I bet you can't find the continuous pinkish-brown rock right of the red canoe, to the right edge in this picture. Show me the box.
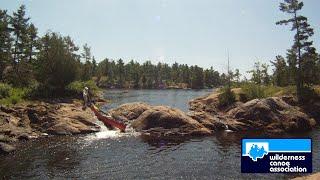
[109,89,320,136]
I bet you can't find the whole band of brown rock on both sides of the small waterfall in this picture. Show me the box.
[0,90,320,154]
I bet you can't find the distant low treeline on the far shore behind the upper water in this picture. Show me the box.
[94,59,231,89]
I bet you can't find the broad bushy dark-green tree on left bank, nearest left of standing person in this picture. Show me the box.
[36,33,78,95]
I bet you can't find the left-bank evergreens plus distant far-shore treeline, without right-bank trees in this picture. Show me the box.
[0,5,232,94]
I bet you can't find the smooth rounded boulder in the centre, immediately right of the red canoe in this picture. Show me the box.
[110,103,212,136]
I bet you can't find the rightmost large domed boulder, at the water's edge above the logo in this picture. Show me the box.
[227,97,316,132]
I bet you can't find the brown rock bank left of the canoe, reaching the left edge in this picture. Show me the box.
[0,100,100,154]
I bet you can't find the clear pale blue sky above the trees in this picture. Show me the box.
[0,0,320,76]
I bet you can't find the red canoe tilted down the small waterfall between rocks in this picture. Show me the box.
[90,104,126,132]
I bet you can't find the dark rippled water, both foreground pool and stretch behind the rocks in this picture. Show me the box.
[0,90,320,179]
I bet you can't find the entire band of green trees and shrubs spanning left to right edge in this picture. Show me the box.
[0,1,320,103]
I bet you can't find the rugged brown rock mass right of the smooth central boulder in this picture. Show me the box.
[189,89,319,133]
